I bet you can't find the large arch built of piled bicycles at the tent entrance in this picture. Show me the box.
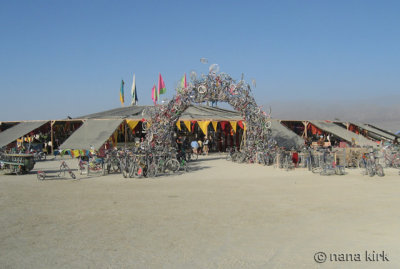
[144,65,271,161]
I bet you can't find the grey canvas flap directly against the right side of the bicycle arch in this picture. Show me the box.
[271,119,304,149]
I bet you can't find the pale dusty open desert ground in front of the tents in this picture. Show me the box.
[0,155,400,268]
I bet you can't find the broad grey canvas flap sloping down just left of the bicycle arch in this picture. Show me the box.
[60,119,123,150]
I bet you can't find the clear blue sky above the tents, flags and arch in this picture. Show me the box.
[0,0,400,121]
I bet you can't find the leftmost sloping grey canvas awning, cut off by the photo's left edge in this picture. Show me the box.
[0,121,49,148]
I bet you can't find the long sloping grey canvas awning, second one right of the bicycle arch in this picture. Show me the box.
[310,121,377,147]
